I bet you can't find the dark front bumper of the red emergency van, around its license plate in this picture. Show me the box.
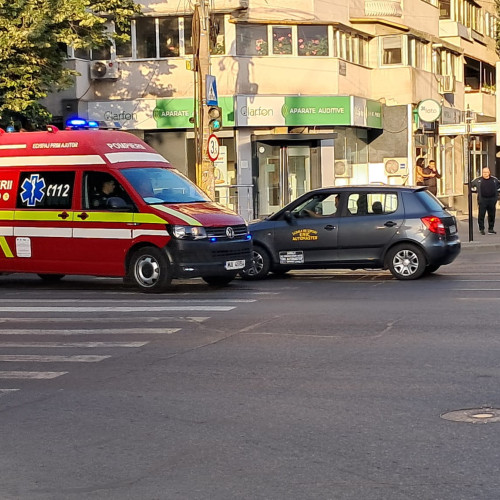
[165,238,252,278]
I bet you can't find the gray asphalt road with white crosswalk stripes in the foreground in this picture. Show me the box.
[0,251,500,500]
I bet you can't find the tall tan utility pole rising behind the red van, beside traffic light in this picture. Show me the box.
[192,0,215,199]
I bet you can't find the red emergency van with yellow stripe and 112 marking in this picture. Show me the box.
[0,127,251,292]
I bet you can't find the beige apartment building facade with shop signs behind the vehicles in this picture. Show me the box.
[47,0,497,220]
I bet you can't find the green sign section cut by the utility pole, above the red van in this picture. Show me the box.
[153,97,234,129]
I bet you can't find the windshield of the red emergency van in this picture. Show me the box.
[121,168,210,205]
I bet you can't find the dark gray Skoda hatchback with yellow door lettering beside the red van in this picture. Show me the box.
[242,184,460,280]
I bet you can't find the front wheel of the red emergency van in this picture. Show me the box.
[127,247,172,293]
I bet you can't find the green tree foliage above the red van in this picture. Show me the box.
[0,0,139,129]
